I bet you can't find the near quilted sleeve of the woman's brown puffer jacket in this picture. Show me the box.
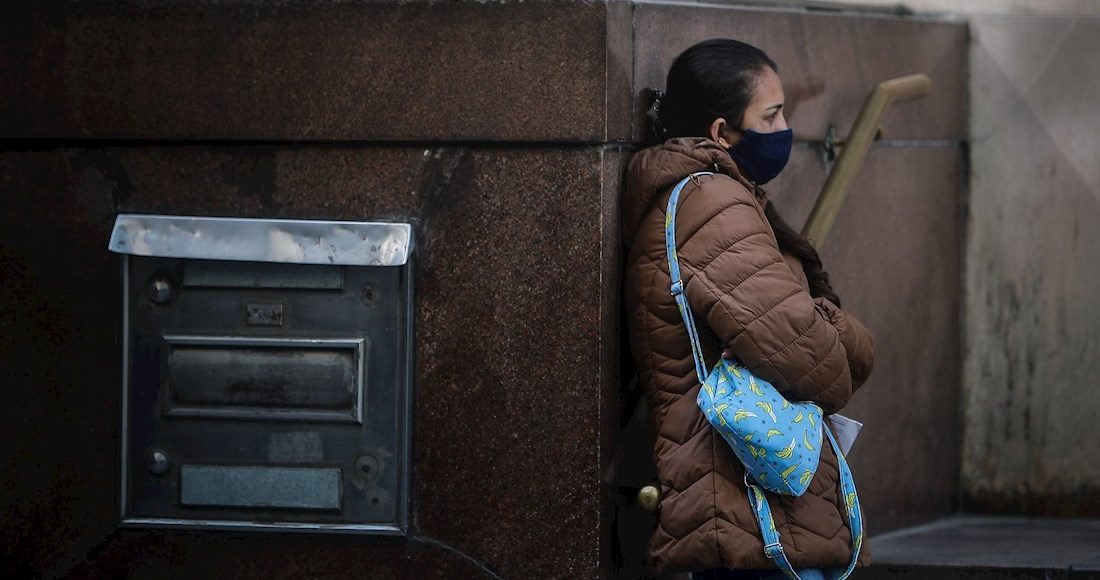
[677,176,869,414]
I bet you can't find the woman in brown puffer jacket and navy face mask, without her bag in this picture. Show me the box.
[623,40,873,578]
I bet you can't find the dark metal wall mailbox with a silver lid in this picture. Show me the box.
[110,215,413,534]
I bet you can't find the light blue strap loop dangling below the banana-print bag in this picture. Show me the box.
[745,425,864,580]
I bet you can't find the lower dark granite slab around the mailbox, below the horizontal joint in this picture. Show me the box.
[0,145,618,578]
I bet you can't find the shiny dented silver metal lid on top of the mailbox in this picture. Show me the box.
[108,214,413,266]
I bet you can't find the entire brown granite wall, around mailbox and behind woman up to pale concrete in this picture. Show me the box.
[0,0,967,578]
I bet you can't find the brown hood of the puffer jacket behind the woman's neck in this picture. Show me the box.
[623,138,763,248]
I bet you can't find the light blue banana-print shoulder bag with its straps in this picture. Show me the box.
[664,172,864,579]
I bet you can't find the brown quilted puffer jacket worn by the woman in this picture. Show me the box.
[623,139,873,572]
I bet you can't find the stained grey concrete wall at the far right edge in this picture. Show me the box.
[827,0,1100,515]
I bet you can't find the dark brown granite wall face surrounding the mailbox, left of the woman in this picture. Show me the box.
[0,0,631,578]
